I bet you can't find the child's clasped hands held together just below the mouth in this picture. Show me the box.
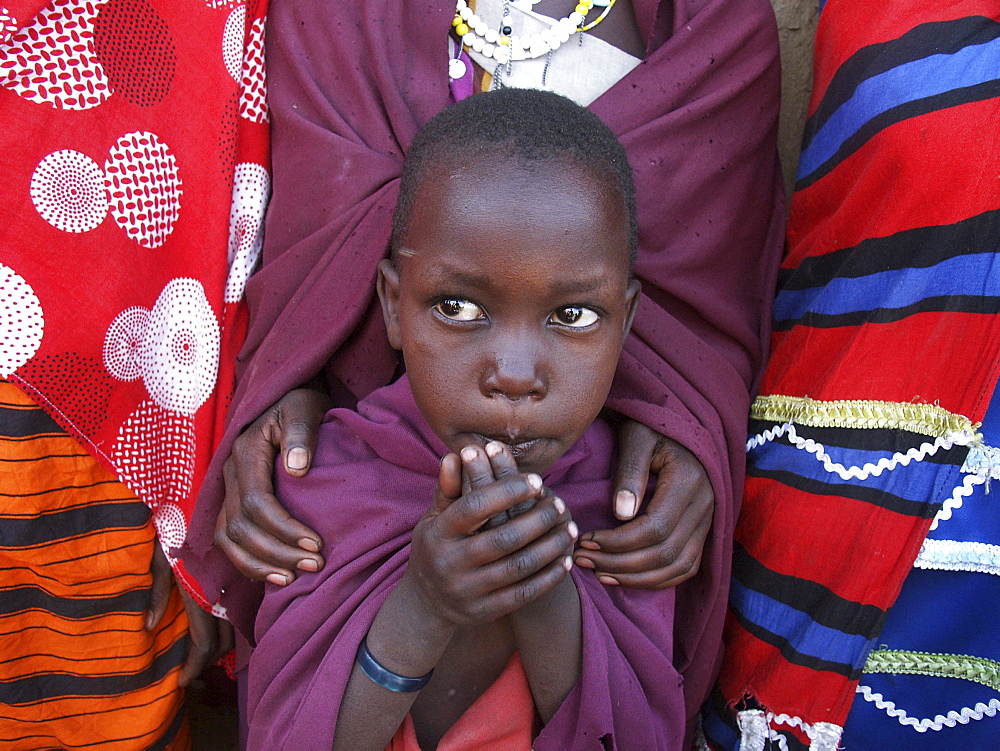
[407,442,577,625]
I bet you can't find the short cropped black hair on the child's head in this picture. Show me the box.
[391,88,638,266]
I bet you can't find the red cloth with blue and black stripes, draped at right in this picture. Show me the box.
[704,0,1000,750]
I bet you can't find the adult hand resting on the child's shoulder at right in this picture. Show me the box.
[576,419,715,589]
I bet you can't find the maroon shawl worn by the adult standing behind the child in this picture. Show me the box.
[185,0,784,717]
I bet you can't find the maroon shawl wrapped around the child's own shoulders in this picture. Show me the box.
[248,377,685,751]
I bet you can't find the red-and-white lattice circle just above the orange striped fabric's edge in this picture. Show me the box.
[111,400,195,520]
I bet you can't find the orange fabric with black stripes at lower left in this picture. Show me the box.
[0,382,190,751]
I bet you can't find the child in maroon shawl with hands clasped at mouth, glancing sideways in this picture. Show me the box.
[241,89,684,750]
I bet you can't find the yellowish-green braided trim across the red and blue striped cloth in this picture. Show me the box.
[750,394,979,438]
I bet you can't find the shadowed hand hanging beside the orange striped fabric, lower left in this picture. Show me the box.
[146,540,234,688]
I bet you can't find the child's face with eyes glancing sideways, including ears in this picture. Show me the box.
[379,158,639,473]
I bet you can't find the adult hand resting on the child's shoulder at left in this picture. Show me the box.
[215,388,333,585]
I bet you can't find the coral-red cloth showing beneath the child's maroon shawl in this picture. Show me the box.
[386,652,535,751]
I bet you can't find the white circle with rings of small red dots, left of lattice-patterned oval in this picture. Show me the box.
[29,149,108,232]
